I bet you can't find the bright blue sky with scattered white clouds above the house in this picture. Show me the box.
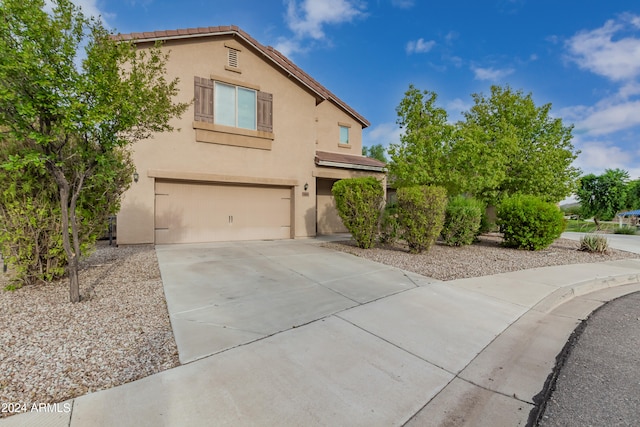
[74,0,640,178]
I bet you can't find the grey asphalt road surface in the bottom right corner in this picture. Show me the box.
[538,292,640,427]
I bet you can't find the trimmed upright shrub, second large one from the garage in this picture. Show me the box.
[397,186,447,253]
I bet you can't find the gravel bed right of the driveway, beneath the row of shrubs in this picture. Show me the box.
[323,234,640,281]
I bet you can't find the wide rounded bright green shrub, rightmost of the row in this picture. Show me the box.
[497,194,564,251]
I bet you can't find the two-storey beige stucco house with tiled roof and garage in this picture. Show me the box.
[117,27,385,244]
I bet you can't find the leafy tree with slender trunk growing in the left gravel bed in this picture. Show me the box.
[0,0,187,302]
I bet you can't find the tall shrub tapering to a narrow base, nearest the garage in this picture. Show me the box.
[331,177,384,249]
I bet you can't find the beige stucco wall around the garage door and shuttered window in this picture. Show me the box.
[118,36,376,244]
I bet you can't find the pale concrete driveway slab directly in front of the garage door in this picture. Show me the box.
[156,240,436,363]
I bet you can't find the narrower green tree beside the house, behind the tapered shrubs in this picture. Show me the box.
[388,85,454,189]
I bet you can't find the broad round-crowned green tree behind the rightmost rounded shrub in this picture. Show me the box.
[452,86,579,204]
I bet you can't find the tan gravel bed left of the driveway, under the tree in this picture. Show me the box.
[0,242,179,417]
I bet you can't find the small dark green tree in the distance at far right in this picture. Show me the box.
[576,169,629,230]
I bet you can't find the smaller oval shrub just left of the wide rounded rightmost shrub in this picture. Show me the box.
[441,196,485,246]
